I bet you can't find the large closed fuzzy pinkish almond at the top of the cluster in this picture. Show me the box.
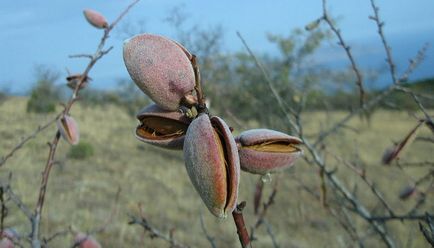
[123,34,195,111]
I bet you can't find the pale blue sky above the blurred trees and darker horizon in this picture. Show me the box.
[0,0,434,93]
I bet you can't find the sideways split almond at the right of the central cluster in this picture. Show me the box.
[236,129,303,175]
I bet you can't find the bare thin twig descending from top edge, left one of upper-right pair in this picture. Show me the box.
[322,0,365,107]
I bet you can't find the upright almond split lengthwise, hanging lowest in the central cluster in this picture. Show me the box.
[184,114,240,218]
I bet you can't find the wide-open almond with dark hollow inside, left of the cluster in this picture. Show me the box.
[136,104,191,150]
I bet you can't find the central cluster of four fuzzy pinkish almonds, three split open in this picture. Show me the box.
[123,34,303,218]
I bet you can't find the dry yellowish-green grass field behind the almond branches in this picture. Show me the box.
[0,97,434,247]
